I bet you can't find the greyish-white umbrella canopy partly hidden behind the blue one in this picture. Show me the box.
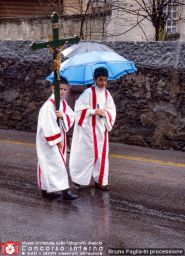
[62,42,114,58]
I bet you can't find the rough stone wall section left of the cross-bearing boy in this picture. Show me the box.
[0,41,52,131]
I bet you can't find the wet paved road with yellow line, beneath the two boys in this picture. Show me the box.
[0,130,185,255]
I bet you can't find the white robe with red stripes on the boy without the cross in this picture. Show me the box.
[69,86,116,186]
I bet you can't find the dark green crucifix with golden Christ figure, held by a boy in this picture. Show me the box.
[30,12,80,114]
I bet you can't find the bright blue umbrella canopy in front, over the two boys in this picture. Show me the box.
[46,50,137,85]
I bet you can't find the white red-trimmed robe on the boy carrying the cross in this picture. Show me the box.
[36,95,74,192]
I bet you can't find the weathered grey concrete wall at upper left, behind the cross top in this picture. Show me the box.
[0,16,109,41]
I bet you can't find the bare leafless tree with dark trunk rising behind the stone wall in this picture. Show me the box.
[108,0,185,41]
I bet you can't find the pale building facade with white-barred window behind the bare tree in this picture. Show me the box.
[106,0,185,41]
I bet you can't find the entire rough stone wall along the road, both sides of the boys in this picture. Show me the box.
[0,41,185,150]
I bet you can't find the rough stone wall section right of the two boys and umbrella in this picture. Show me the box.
[109,42,185,150]
